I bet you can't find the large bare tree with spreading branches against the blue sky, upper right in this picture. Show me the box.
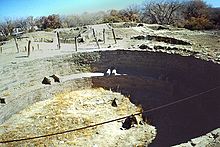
[143,0,182,24]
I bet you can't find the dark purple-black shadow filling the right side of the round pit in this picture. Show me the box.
[89,51,220,146]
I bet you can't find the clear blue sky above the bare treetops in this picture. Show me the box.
[0,0,220,21]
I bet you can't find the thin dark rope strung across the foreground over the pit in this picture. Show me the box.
[0,86,220,143]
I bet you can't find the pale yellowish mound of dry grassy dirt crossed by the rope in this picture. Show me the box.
[0,89,156,146]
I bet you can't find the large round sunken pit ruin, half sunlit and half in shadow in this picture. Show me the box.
[0,24,220,146]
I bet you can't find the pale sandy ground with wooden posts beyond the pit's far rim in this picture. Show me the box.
[0,23,220,65]
